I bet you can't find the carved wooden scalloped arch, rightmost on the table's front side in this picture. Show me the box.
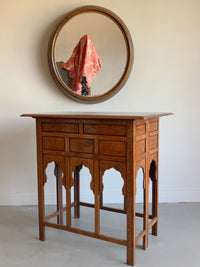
[99,161,127,196]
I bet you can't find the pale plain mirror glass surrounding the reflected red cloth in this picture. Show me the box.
[54,13,127,96]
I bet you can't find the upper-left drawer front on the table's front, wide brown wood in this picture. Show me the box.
[42,122,79,133]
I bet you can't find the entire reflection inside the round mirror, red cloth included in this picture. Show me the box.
[55,13,127,96]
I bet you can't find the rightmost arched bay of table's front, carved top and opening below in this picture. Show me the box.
[99,160,126,239]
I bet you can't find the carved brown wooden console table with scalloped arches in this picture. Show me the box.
[22,113,171,265]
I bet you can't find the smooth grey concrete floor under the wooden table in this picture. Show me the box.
[0,203,200,267]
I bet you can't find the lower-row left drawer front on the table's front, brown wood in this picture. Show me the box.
[42,136,65,151]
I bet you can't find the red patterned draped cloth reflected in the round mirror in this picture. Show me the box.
[62,35,101,94]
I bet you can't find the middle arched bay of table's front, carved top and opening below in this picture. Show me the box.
[70,158,95,231]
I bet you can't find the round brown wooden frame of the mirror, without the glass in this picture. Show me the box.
[48,5,134,104]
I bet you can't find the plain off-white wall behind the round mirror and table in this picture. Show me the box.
[0,0,200,205]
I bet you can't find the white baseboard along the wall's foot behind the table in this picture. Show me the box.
[0,191,200,206]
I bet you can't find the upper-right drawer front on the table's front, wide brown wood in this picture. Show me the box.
[83,124,126,136]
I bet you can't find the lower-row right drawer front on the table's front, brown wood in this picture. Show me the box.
[99,141,126,157]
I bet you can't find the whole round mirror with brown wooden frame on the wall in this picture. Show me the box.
[49,6,133,103]
